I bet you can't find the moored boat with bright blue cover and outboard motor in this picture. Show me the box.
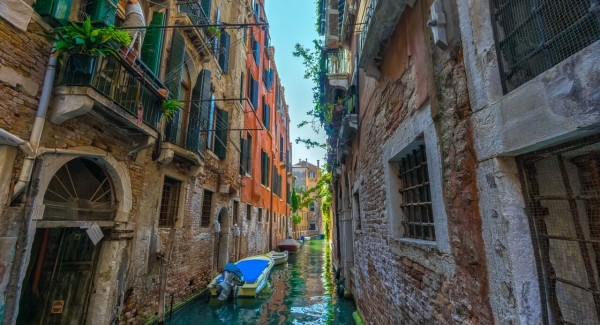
[208,254,275,300]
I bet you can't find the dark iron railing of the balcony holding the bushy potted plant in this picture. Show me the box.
[62,51,166,130]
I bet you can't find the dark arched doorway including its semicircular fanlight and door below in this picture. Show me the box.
[17,158,117,324]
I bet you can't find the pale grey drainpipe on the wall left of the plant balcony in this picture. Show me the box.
[10,46,58,203]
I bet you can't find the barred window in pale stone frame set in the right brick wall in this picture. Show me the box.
[398,144,435,241]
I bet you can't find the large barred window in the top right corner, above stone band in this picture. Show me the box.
[491,0,600,93]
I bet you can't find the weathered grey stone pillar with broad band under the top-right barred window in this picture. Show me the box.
[457,1,600,324]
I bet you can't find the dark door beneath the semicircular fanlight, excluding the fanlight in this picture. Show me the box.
[17,228,102,325]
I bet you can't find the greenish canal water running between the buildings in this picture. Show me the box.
[165,240,355,325]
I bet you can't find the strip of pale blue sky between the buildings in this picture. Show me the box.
[265,0,325,166]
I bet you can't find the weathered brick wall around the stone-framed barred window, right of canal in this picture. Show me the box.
[346,1,493,324]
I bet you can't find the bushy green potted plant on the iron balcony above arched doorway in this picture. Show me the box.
[43,17,131,74]
